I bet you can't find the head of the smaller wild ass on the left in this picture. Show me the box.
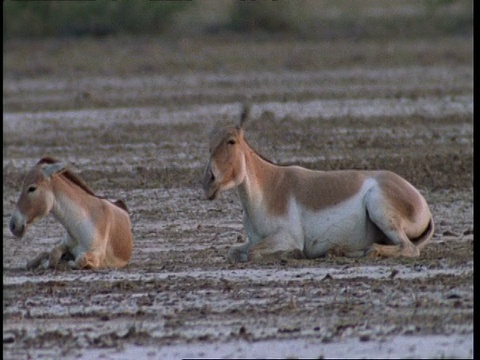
[10,158,66,237]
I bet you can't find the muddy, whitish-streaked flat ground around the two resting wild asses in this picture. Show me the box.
[3,34,474,359]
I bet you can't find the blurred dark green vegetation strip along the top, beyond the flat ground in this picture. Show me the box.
[3,0,473,39]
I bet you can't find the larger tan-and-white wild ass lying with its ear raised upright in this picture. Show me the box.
[203,107,434,262]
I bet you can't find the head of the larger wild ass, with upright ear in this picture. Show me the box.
[203,106,249,200]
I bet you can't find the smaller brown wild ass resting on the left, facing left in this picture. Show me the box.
[10,157,133,269]
